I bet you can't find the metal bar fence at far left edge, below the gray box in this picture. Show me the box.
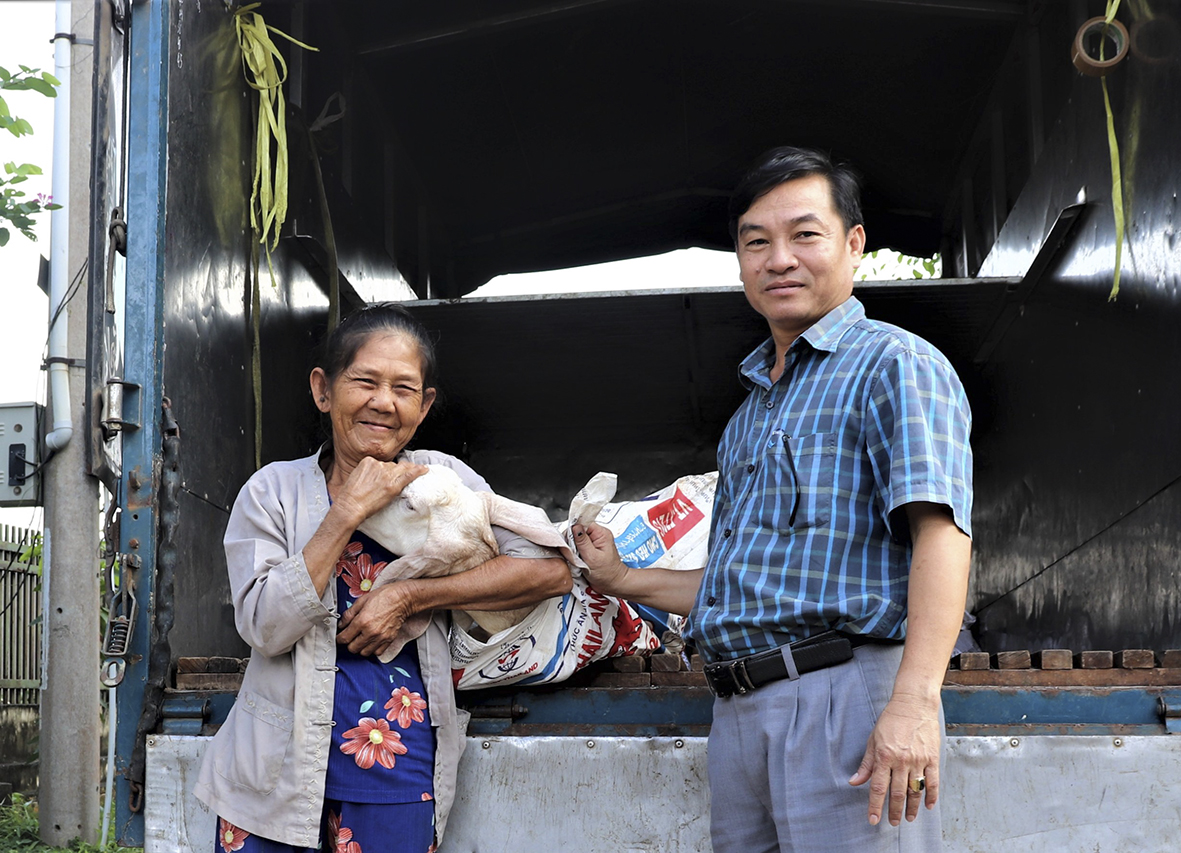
[0,525,41,708]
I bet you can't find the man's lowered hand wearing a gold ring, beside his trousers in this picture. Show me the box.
[849,695,941,826]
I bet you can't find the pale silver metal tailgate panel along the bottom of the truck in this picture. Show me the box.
[144,735,1181,853]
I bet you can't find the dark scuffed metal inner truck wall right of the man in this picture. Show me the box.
[970,4,1181,651]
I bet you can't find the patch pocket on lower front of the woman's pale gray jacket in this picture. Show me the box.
[215,690,294,794]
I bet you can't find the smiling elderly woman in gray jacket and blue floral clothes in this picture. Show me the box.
[196,304,570,853]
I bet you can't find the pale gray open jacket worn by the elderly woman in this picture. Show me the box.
[195,450,529,847]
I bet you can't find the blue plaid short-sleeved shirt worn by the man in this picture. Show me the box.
[687,297,972,660]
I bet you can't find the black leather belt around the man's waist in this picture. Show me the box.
[705,631,875,698]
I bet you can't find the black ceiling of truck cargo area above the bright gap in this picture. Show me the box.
[292,0,1072,292]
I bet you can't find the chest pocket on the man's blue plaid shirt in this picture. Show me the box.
[768,432,836,530]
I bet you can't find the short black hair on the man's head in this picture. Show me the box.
[730,145,863,245]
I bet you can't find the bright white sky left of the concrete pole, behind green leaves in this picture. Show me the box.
[0,0,54,527]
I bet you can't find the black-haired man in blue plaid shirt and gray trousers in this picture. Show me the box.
[575,148,972,853]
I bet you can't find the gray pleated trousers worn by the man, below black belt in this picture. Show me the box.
[709,645,946,853]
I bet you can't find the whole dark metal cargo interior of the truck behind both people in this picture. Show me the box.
[147,0,1181,655]
